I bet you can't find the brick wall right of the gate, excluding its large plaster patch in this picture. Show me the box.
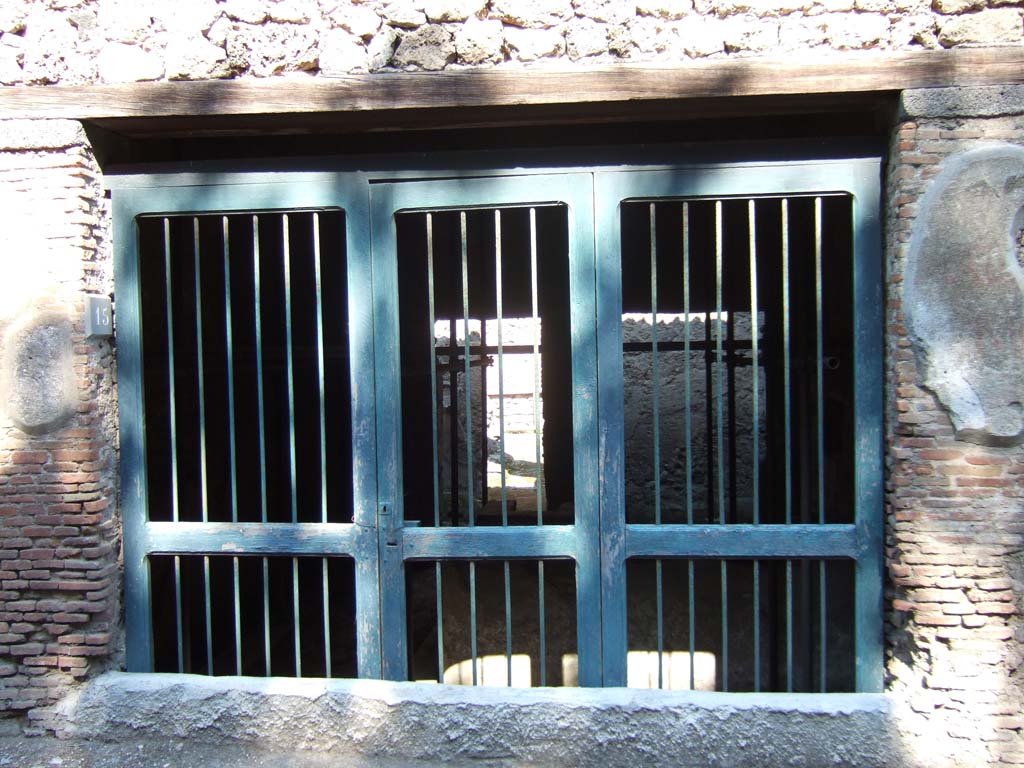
[886,111,1024,766]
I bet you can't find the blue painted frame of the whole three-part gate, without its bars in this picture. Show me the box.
[113,151,883,691]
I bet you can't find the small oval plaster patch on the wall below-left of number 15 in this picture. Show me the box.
[0,311,78,434]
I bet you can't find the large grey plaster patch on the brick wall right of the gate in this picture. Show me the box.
[904,144,1024,445]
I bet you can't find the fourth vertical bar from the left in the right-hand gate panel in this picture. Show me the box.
[746,200,761,692]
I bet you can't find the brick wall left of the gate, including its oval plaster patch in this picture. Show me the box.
[0,121,121,712]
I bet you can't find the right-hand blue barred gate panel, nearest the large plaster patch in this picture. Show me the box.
[595,161,883,691]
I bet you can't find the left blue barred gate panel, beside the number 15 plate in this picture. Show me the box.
[115,175,380,677]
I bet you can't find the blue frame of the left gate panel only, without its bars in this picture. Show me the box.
[113,173,381,678]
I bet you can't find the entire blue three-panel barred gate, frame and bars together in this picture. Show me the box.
[114,153,882,690]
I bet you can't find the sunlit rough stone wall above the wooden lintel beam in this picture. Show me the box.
[0,0,1024,85]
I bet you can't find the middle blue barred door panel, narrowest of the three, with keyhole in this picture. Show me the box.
[371,173,600,685]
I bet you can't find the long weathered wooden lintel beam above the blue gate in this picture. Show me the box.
[0,46,1024,120]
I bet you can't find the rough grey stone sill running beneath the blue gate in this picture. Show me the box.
[44,673,906,768]
